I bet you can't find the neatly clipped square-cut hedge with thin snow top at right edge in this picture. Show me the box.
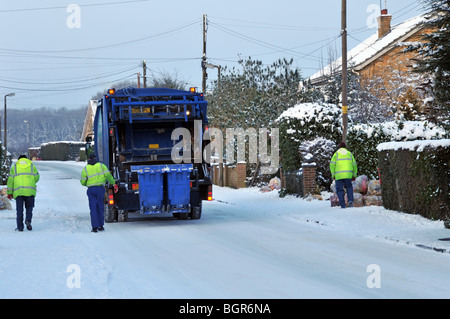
[377,139,450,220]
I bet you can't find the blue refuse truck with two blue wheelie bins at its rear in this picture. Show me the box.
[86,88,212,222]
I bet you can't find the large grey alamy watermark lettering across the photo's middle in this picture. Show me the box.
[171,120,279,174]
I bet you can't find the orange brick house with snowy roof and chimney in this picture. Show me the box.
[310,9,431,111]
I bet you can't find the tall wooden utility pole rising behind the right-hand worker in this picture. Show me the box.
[341,0,348,142]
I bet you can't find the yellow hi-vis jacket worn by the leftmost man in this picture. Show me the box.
[7,158,39,198]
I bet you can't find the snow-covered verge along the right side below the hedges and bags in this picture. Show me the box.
[229,186,450,255]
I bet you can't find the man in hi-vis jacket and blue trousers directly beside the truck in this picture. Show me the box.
[80,154,117,233]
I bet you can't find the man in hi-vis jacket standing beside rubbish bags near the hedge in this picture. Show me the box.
[330,142,358,208]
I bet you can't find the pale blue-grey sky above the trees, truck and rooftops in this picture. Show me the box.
[0,0,425,110]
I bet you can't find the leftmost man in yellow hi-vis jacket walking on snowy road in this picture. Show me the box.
[7,155,39,231]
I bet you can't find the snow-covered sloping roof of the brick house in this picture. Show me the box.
[310,14,426,82]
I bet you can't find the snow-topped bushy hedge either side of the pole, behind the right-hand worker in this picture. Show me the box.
[277,103,448,185]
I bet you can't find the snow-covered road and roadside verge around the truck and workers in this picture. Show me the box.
[0,162,450,299]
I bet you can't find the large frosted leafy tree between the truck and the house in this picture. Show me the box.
[207,58,320,129]
